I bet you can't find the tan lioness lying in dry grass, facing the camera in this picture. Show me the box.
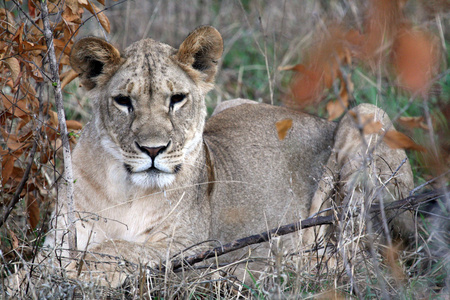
[27,26,412,285]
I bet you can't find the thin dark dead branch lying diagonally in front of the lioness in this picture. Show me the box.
[168,190,447,271]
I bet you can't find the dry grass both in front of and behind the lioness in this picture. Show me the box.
[0,0,450,299]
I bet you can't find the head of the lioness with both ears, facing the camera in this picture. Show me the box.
[70,26,223,187]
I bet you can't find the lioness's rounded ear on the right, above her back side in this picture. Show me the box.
[176,26,223,83]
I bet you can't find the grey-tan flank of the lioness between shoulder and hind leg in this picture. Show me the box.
[204,104,336,240]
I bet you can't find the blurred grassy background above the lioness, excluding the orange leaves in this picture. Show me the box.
[74,0,450,113]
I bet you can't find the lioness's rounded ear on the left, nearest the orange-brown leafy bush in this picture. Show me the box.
[70,37,122,90]
